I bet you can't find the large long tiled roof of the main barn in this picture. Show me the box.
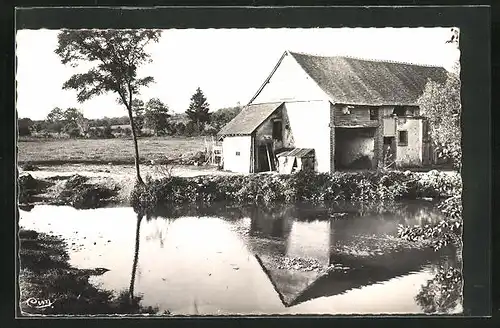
[288,52,447,106]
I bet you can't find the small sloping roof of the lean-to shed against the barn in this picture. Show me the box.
[218,102,283,136]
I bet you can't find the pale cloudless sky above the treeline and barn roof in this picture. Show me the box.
[16,27,460,120]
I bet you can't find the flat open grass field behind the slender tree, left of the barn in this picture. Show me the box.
[18,137,205,165]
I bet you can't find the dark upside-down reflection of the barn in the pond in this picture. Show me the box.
[244,206,449,306]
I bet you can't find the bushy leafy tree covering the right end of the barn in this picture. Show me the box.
[418,73,462,168]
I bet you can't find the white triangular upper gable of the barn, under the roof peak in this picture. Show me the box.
[252,55,327,104]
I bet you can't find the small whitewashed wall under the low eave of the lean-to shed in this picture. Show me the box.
[222,136,252,173]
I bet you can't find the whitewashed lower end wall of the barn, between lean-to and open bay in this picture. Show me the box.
[284,101,330,172]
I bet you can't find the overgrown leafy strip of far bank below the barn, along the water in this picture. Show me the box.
[131,171,461,211]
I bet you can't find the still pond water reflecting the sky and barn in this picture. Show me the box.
[20,203,460,315]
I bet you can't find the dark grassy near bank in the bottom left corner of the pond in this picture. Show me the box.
[19,230,157,315]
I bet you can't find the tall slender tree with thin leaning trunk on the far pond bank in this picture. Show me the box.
[55,29,161,184]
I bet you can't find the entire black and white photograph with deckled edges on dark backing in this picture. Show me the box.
[15,15,464,318]
